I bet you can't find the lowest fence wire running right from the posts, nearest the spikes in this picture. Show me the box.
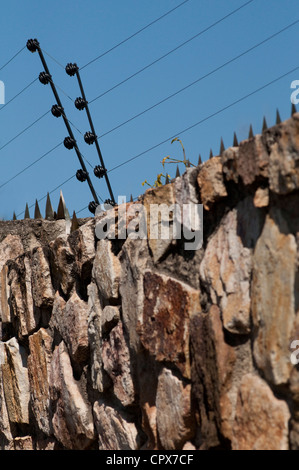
[108,62,299,173]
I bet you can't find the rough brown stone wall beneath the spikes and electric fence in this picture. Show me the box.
[0,114,299,450]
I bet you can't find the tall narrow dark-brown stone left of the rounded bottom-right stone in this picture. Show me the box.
[190,305,238,449]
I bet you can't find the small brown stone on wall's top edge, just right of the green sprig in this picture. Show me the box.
[197,157,227,210]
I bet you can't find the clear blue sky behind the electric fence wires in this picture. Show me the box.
[0,0,299,219]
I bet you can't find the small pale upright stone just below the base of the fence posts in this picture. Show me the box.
[93,240,121,300]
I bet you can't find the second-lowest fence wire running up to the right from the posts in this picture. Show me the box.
[97,19,299,139]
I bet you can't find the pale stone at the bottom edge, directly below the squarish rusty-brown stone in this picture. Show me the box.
[156,368,195,450]
